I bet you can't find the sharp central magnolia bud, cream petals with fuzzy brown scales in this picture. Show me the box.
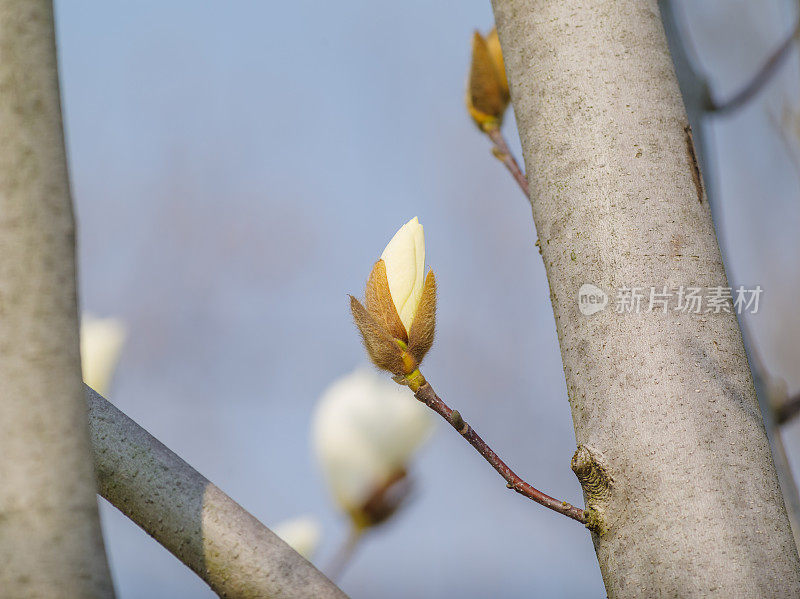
[350,217,436,376]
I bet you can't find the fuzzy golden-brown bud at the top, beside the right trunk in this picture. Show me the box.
[467,28,511,131]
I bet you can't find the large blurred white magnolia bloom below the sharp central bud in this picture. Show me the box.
[312,370,433,528]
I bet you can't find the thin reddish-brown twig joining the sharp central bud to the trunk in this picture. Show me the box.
[414,382,586,524]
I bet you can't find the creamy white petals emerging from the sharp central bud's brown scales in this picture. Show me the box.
[381,216,425,333]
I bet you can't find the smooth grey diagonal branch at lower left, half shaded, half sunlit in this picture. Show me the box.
[86,387,346,599]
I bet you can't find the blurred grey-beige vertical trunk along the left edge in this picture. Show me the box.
[0,0,113,598]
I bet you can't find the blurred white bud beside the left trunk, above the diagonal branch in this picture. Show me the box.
[81,314,127,396]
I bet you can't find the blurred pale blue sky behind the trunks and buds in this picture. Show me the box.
[56,0,800,599]
